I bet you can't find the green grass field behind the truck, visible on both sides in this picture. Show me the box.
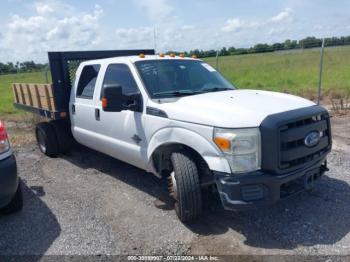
[0,46,350,119]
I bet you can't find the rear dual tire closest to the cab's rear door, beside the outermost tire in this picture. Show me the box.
[50,120,72,154]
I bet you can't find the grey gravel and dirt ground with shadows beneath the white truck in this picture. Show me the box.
[0,117,350,256]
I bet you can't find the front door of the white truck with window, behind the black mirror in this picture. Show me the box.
[95,63,147,168]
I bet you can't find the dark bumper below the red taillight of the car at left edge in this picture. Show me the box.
[0,155,18,208]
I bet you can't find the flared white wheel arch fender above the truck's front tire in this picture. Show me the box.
[147,127,231,173]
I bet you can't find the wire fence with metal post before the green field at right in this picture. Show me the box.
[208,42,350,113]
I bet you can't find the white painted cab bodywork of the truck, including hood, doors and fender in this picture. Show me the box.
[70,56,314,174]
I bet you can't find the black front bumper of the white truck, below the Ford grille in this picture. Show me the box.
[214,159,328,210]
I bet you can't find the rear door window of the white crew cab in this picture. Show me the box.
[77,65,101,99]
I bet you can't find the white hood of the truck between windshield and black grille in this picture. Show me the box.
[152,90,315,128]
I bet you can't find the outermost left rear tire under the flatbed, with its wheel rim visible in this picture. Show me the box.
[35,122,59,157]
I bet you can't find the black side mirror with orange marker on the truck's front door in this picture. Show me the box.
[102,84,124,112]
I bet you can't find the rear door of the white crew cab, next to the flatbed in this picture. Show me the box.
[70,64,101,148]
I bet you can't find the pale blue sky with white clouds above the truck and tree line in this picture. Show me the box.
[0,0,350,62]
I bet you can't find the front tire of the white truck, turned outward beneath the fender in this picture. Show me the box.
[169,152,202,222]
